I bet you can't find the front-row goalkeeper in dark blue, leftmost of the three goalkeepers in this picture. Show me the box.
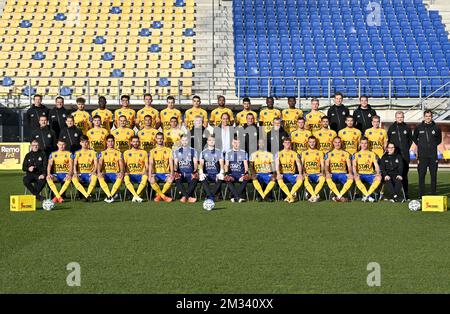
[173,134,198,203]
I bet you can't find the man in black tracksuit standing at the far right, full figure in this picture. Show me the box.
[413,110,442,198]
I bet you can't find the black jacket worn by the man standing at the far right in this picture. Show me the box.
[413,121,442,160]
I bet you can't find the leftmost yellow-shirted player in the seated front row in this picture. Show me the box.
[47,139,73,203]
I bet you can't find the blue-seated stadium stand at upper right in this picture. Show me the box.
[233,0,450,98]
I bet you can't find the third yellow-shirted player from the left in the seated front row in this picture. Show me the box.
[98,134,124,203]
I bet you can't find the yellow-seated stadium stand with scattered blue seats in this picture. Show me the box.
[0,0,196,98]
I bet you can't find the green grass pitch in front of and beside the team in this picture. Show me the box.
[0,171,450,293]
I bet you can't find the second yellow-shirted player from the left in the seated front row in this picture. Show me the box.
[72,135,97,202]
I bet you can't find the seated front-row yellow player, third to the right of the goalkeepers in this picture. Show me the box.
[300,136,325,202]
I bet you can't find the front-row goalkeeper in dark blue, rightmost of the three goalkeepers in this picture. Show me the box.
[225,137,250,203]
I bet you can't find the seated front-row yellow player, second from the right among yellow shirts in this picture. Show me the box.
[325,136,353,202]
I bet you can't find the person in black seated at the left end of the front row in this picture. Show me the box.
[22,140,47,201]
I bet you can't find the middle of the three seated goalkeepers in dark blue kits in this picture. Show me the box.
[198,135,225,201]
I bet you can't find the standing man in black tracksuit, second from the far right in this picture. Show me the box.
[387,111,412,199]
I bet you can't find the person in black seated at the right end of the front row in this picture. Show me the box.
[379,143,403,202]
